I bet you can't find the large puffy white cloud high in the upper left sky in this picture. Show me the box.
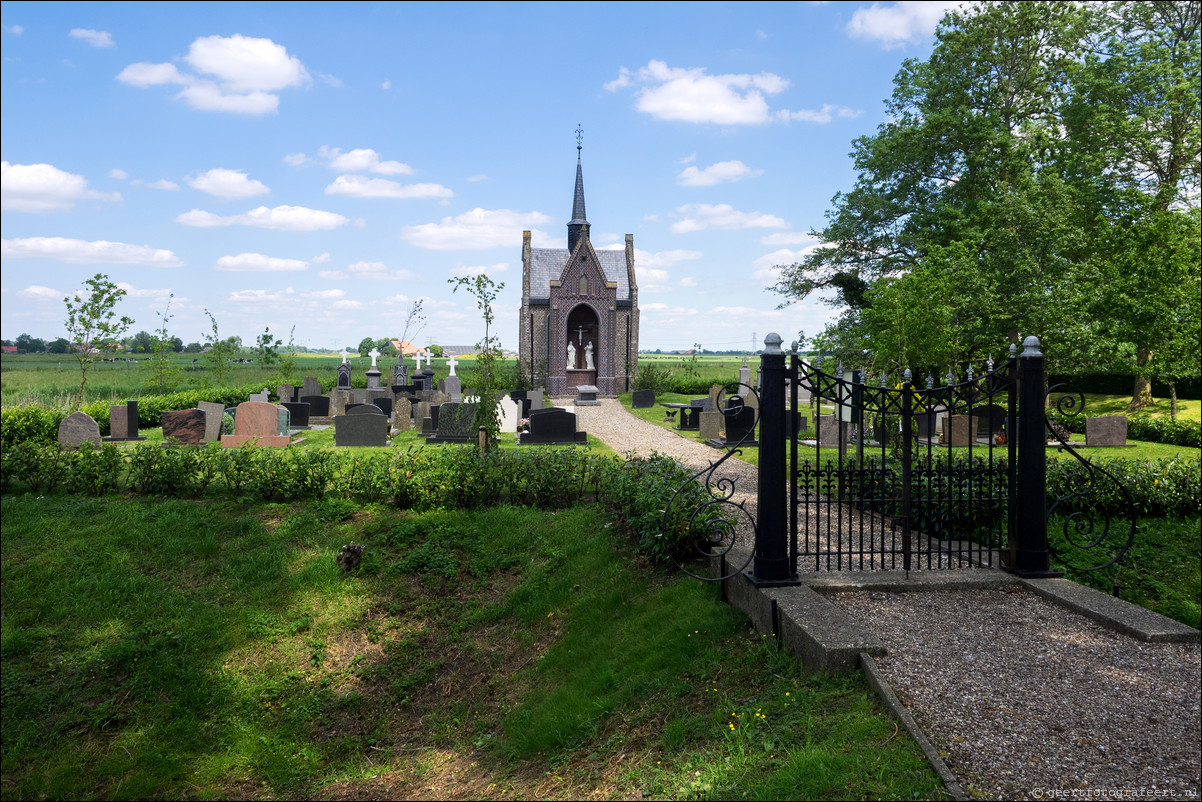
[117,34,310,114]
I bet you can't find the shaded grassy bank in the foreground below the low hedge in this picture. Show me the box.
[0,495,942,798]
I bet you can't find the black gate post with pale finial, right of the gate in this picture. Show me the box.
[1012,335,1064,577]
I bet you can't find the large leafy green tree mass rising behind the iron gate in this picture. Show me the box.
[775,2,1198,399]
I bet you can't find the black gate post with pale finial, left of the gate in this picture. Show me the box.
[745,332,798,588]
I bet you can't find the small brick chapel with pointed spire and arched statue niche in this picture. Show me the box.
[518,142,638,396]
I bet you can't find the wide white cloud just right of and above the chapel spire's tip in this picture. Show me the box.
[605,59,859,125]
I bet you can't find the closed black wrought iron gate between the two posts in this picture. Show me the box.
[786,346,1019,571]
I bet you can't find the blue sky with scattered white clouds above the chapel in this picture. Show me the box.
[0,2,952,350]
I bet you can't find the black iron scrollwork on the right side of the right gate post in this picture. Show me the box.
[1043,385,1136,571]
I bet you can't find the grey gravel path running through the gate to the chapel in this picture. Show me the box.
[576,399,1202,800]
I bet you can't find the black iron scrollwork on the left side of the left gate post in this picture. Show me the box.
[660,381,760,582]
